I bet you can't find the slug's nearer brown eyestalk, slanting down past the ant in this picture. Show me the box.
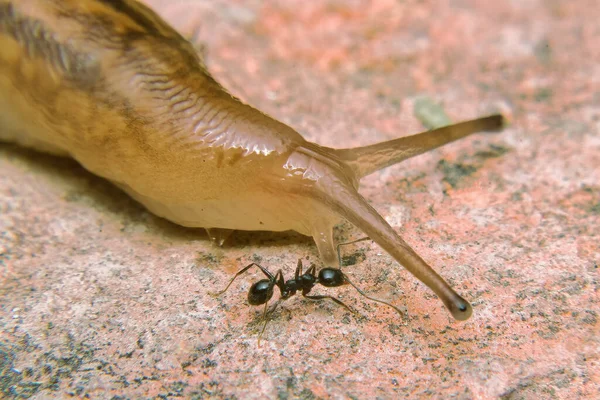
[316,180,472,321]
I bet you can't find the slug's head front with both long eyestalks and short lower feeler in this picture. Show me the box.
[278,115,503,321]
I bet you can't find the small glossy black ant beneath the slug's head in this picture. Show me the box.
[212,237,403,343]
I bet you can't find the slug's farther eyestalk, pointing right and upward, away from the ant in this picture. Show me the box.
[335,114,504,178]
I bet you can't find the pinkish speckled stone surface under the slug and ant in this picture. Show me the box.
[0,0,600,399]
